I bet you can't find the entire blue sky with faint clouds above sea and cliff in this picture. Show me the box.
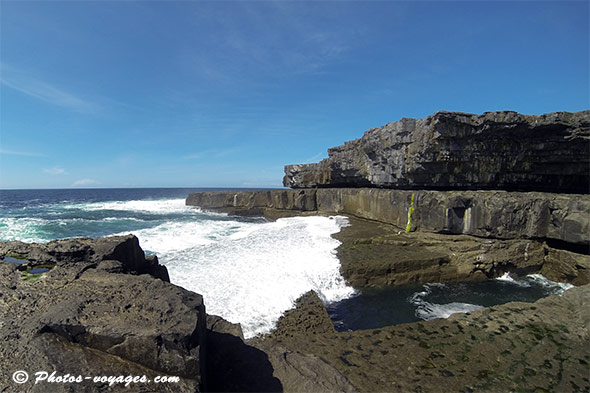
[0,0,590,188]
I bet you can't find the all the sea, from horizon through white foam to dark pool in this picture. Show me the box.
[0,188,568,338]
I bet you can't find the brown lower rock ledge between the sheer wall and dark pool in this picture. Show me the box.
[333,218,590,288]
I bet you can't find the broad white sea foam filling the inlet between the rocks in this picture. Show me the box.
[135,217,354,337]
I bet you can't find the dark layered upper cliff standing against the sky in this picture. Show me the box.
[283,111,590,194]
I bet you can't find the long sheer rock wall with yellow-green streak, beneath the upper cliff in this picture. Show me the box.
[186,188,590,245]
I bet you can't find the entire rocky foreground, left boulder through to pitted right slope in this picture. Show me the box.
[0,236,590,392]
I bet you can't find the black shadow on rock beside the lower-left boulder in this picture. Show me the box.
[204,331,283,392]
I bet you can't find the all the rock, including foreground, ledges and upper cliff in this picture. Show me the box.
[0,111,590,392]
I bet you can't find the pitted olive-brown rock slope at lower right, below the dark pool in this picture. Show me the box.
[255,285,590,392]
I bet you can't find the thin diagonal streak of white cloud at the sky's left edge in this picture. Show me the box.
[0,64,98,113]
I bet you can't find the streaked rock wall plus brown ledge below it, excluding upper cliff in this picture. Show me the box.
[187,188,590,287]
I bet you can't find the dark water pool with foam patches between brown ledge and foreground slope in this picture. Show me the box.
[327,273,573,331]
